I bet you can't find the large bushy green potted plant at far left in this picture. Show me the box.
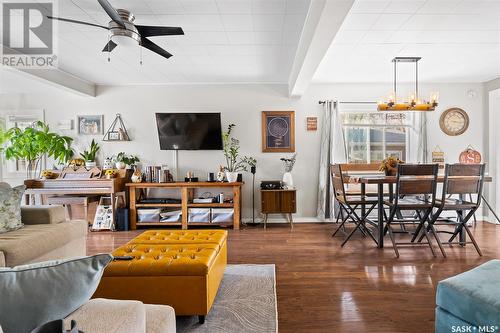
[0,121,74,179]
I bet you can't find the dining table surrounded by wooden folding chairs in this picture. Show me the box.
[356,175,499,248]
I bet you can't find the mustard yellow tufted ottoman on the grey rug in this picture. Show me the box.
[93,230,227,323]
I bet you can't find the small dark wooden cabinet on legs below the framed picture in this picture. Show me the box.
[260,189,297,229]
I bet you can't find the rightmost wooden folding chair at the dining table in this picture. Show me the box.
[419,164,486,257]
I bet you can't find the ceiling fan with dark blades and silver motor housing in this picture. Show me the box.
[47,0,184,59]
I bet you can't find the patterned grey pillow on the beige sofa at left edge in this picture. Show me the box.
[0,185,26,234]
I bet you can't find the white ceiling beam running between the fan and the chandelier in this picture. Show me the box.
[288,0,354,97]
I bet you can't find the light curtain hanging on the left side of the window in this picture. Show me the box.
[317,101,347,220]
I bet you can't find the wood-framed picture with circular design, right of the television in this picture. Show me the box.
[262,111,295,153]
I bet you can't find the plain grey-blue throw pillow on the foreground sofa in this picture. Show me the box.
[0,254,113,333]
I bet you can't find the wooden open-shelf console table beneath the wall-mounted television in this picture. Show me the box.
[127,182,244,230]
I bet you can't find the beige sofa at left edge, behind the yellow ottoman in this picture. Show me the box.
[0,206,88,267]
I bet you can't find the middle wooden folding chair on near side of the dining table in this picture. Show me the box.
[384,164,438,258]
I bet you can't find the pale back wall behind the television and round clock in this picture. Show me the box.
[0,84,485,220]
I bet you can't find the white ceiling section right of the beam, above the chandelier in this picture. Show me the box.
[313,0,500,83]
